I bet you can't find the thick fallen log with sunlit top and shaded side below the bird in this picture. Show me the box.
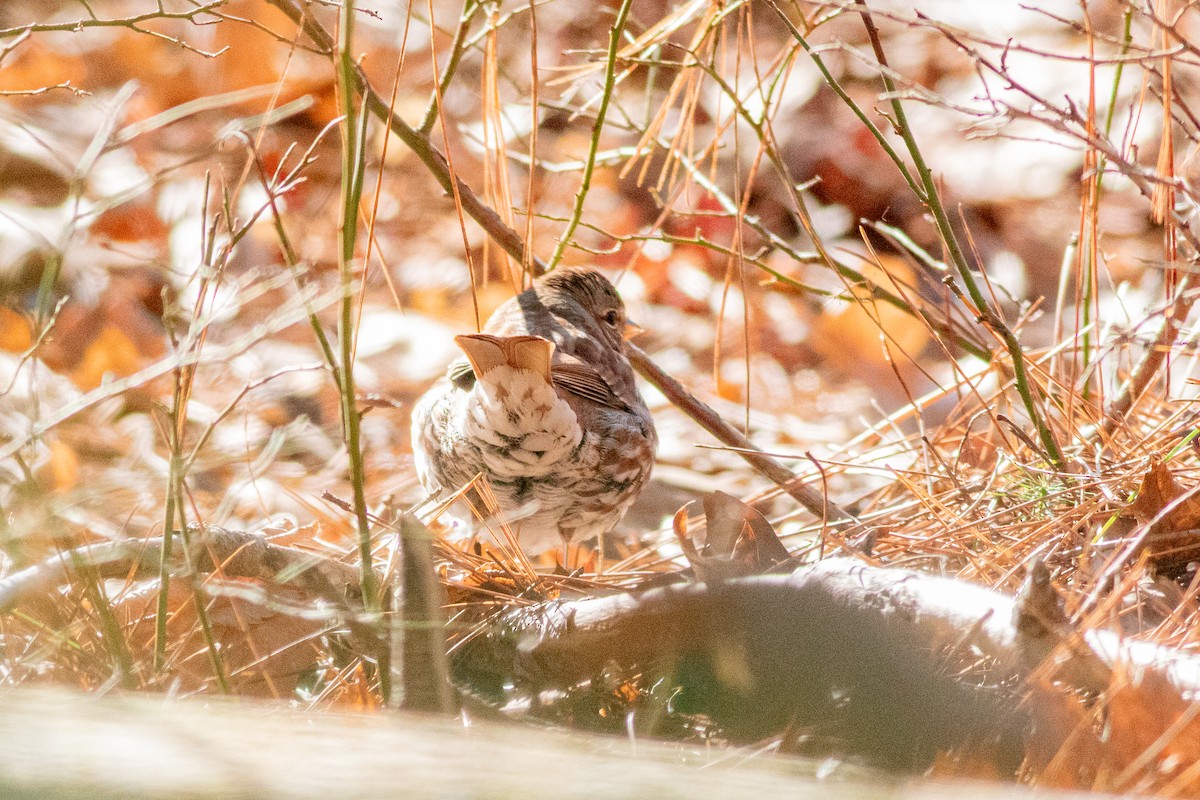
[456,559,1200,769]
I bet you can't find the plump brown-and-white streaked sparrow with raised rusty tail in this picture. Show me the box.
[413,269,658,552]
